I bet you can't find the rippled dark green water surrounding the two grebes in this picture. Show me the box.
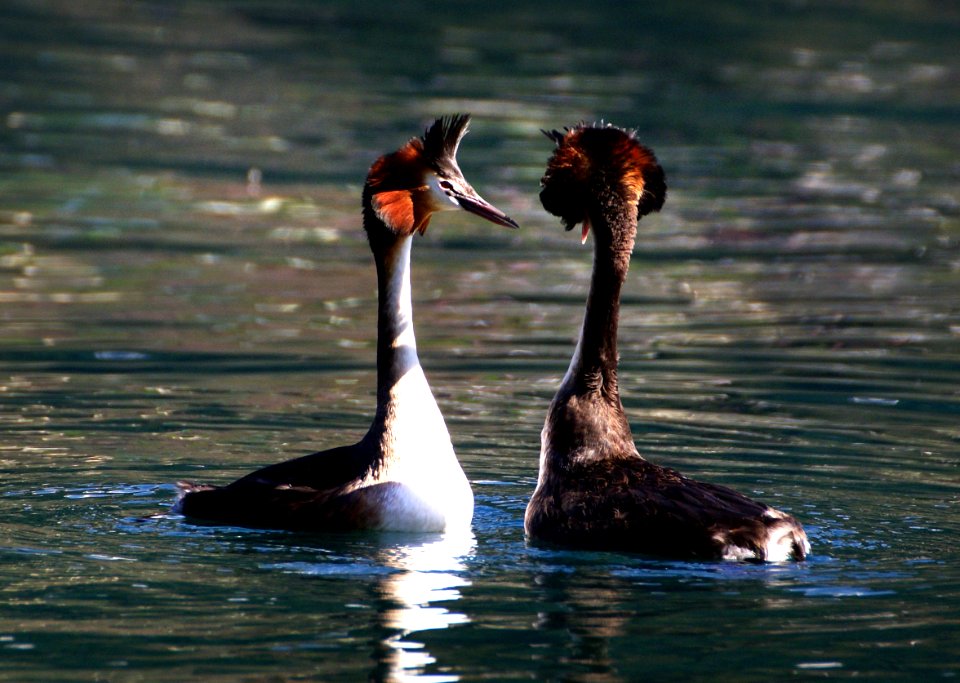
[0,0,960,681]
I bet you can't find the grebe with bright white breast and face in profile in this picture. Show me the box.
[174,115,518,532]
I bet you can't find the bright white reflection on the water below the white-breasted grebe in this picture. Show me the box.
[380,531,476,683]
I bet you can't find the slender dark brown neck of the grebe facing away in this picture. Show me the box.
[567,192,637,404]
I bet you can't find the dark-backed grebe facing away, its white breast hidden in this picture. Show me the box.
[524,124,810,561]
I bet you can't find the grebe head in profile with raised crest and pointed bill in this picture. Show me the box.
[363,114,519,236]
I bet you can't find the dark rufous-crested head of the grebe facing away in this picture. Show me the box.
[540,124,667,242]
